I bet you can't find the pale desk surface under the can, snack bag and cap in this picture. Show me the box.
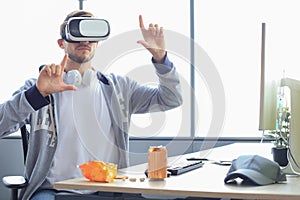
[55,143,300,200]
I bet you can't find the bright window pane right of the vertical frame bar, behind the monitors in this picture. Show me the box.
[195,0,300,137]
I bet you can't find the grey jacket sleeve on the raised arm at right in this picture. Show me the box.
[129,56,182,113]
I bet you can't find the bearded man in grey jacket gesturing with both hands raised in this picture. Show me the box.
[0,10,182,200]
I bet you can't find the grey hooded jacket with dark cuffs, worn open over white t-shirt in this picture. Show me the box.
[0,57,182,200]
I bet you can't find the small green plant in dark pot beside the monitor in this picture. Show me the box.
[264,107,291,167]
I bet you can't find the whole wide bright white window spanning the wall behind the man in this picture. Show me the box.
[0,0,300,138]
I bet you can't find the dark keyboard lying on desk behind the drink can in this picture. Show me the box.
[167,160,204,175]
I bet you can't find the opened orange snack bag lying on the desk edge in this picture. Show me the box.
[78,160,117,183]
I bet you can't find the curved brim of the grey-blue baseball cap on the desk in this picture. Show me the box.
[224,169,275,185]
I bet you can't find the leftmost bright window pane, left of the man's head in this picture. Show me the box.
[0,0,78,102]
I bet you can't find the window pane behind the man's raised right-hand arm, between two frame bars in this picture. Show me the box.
[84,0,190,137]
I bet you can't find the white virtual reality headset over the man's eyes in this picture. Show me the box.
[63,17,110,42]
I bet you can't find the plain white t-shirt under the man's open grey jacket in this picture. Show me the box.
[47,77,119,190]
